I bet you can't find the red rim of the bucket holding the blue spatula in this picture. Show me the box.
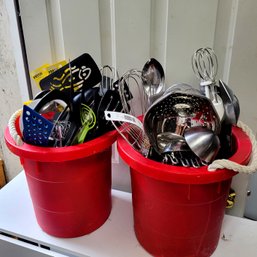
[4,122,117,162]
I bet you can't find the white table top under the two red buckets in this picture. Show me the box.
[0,172,257,257]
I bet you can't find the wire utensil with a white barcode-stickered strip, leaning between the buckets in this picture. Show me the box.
[105,111,150,156]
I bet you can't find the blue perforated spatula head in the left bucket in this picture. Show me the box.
[22,105,54,146]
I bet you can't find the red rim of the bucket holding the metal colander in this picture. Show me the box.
[117,126,252,184]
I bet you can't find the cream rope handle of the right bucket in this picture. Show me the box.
[208,121,257,174]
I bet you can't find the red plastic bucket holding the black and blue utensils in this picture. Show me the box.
[5,118,117,237]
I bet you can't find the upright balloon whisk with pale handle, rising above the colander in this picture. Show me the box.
[192,47,224,120]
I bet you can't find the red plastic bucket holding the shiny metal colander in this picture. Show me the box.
[118,127,252,257]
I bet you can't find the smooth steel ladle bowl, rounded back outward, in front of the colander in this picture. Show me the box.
[184,126,220,163]
